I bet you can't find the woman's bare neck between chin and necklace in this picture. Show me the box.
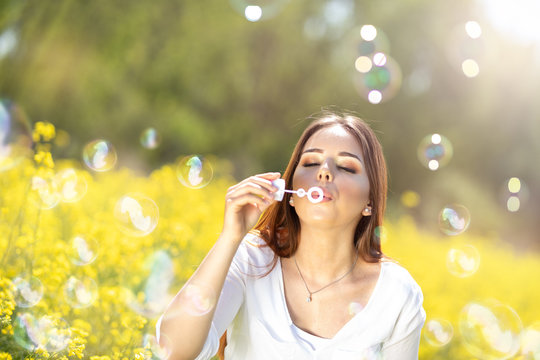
[294,228,357,283]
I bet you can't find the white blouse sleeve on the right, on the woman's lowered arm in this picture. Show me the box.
[382,266,426,360]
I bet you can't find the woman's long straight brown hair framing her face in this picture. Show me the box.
[218,111,388,359]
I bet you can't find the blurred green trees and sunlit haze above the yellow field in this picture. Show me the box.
[0,0,540,251]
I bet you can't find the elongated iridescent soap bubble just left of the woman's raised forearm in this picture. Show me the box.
[125,250,174,318]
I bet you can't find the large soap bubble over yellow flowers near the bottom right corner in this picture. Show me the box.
[459,300,523,359]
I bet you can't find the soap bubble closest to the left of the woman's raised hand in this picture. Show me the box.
[176,155,214,189]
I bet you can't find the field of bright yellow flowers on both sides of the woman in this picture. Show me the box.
[0,125,540,360]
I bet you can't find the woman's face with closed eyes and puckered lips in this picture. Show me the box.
[293,125,369,226]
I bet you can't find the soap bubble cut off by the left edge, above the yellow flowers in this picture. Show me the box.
[0,99,33,172]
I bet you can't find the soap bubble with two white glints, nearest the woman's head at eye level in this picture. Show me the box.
[417,134,453,171]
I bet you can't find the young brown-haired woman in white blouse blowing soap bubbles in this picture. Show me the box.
[157,113,425,360]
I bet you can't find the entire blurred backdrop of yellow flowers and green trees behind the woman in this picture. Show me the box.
[0,0,540,360]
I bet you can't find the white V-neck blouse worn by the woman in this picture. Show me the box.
[157,234,426,360]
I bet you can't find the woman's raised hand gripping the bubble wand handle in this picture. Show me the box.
[222,172,281,242]
